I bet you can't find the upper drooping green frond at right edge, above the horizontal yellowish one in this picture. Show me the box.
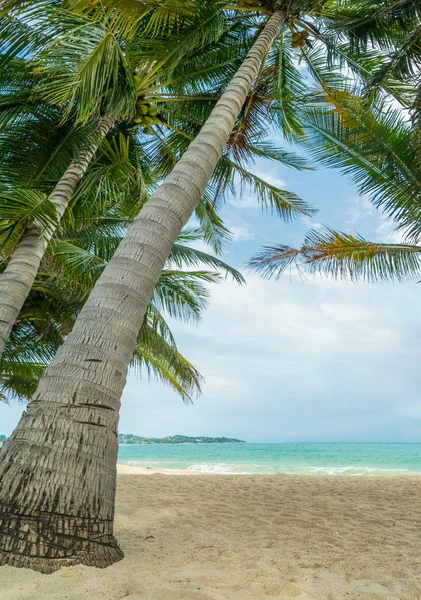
[306,90,421,241]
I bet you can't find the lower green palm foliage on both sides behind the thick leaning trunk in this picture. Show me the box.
[0,127,244,401]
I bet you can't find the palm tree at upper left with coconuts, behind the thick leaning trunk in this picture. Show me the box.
[0,1,305,355]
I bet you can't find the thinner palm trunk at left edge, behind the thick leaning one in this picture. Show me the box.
[0,119,114,357]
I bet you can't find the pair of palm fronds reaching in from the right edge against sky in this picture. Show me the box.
[249,89,421,282]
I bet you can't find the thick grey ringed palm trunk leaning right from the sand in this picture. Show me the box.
[0,12,283,573]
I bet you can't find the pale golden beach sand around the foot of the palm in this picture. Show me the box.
[0,468,421,600]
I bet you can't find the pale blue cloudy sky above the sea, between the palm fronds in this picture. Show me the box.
[0,148,421,442]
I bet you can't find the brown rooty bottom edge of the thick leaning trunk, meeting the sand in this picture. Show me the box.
[0,542,124,574]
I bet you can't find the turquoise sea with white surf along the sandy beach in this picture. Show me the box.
[118,442,421,475]
